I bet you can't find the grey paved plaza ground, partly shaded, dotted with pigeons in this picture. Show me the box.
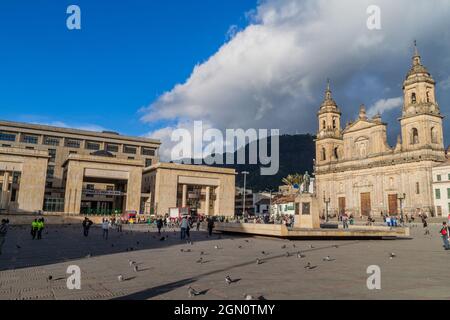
[0,224,450,300]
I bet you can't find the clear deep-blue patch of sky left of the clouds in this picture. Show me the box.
[0,0,256,135]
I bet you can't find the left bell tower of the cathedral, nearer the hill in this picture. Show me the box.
[316,80,343,165]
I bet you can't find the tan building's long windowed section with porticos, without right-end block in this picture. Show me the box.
[0,121,160,214]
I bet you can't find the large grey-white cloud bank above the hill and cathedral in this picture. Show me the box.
[142,0,450,159]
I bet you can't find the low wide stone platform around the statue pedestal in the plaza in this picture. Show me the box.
[215,223,410,240]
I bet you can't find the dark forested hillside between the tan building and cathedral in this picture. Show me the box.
[181,134,315,191]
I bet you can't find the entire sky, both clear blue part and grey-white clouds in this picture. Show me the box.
[0,0,450,156]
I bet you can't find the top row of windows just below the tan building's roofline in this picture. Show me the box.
[0,132,156,157]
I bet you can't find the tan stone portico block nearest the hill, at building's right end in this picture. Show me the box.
[142,163,236,216]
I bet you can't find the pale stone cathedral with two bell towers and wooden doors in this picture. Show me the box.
[315,47,446,217]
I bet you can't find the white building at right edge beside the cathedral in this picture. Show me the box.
[433,158,450,217]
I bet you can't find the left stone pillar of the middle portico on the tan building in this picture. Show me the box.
[64,163,84,214]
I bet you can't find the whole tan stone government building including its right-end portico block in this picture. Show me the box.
[0,121,235,216]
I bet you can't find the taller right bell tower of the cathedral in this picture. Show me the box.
[400,43,444,151]
